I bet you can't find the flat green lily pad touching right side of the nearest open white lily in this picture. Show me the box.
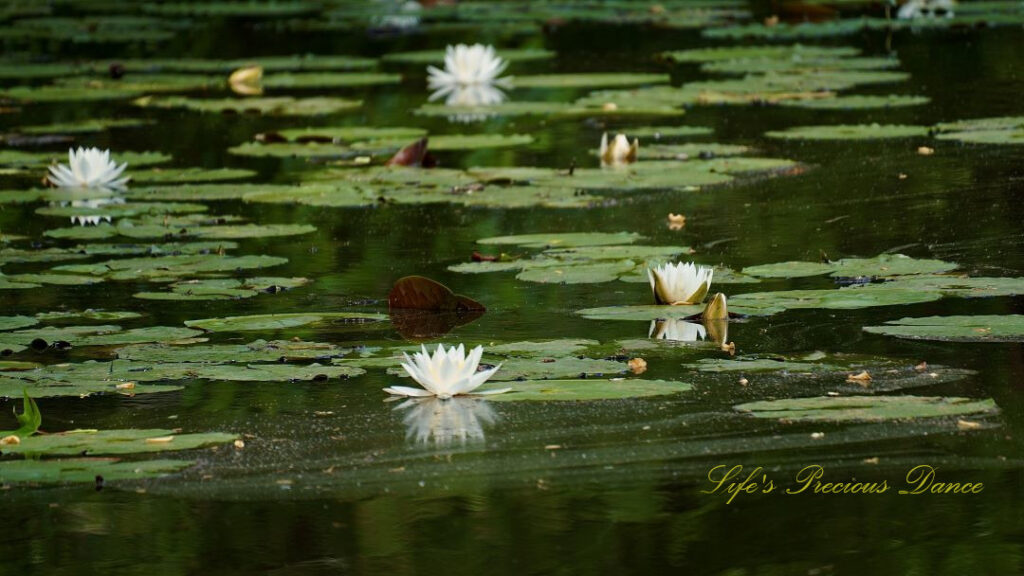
[477,378,692,402]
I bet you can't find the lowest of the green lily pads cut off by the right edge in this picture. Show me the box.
[864,315,1024,342]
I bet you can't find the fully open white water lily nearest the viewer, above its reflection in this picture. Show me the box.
[384,344,512,400]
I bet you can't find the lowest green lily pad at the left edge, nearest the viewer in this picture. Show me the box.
[0,458,195,484]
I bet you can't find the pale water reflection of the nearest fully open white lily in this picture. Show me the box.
[395,398,497,446]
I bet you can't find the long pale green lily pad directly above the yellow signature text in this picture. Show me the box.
[733,396,998,422]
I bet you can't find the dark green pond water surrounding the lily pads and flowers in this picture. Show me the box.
[0,4,1024,575]
